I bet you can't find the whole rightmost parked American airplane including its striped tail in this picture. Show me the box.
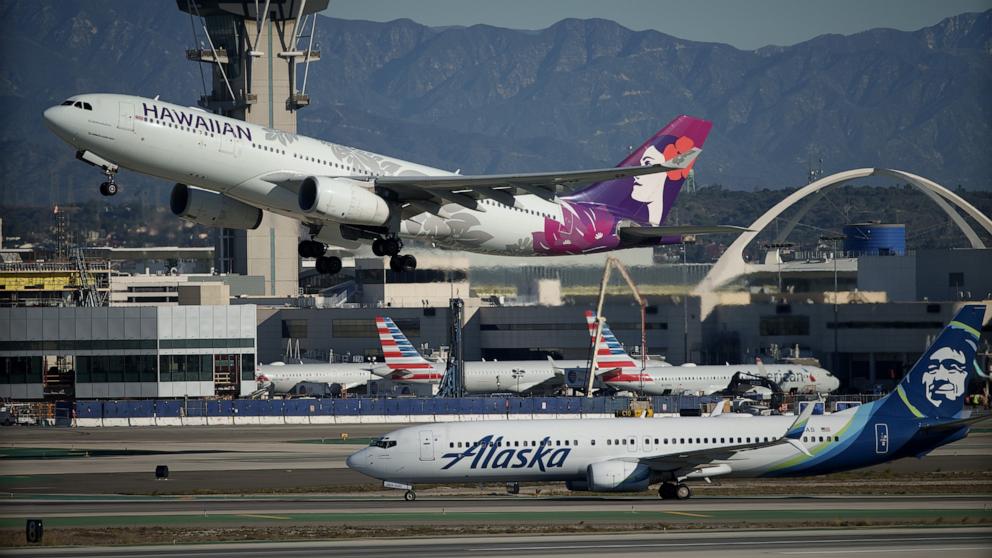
[586,312,840,395]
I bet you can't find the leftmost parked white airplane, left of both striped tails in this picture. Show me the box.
[255,362,389,393]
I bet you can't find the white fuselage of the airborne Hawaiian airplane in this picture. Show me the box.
[45,94,563,256]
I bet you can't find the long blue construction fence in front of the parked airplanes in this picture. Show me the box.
[75,397,702,419]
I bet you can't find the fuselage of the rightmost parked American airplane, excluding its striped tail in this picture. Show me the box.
[603,364,840,395]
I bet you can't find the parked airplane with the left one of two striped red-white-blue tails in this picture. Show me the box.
[375,317,586,393]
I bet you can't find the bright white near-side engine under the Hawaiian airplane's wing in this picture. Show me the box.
[299,176,389,226]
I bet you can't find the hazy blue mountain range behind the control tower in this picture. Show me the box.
[0,0,992,206]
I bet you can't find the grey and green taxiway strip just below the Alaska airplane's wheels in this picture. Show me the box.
[0,496,992,529]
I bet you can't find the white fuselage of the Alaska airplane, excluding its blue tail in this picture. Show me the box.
[348,413,853,484]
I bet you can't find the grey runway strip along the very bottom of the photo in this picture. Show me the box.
[8,528,992,558]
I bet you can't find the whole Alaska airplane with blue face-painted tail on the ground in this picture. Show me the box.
[347,305,985,500]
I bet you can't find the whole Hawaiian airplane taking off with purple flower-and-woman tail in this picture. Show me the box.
[44,94,745,273]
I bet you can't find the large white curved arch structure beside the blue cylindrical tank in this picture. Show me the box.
[692,168,992,304]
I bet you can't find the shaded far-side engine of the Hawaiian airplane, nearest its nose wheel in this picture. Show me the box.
[169,184,262,229]
